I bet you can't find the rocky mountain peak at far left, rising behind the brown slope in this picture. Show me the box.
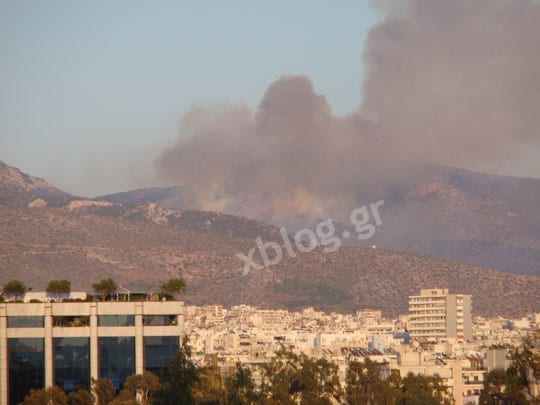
[0,161,71,207]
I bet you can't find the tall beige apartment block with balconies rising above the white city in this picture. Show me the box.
[408,289,472,341]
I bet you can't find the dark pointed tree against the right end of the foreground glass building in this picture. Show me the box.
[153,336,199,405]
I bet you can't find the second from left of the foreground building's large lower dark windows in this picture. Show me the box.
[54,338,90,392]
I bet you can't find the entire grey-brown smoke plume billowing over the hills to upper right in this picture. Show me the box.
[156,0,540,223]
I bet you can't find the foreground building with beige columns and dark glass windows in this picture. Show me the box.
[0,301,184,405]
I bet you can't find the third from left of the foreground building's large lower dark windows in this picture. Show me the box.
[99,337,135,389]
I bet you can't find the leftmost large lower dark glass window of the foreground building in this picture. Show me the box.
[8,338,45,405]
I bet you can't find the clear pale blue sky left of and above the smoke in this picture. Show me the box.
[0,0,377,195]
